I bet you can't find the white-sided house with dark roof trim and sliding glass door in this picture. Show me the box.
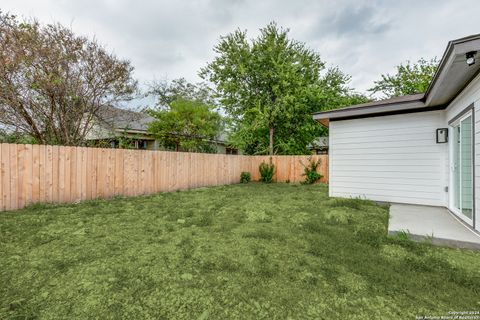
[313,35,480,230]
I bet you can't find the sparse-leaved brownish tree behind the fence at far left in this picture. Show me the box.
[0,11,137,145]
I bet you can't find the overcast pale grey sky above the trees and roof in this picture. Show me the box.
[0,0,480,102]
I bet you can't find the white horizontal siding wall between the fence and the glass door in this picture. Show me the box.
[329,111,447,206]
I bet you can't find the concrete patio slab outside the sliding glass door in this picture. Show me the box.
[388,204,480,250]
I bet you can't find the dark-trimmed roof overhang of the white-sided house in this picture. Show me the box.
[313,34,480,127]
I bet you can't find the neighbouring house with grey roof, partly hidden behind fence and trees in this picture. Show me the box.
[87,107,241,154]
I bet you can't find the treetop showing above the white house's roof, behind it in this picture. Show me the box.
[368,58,438,98]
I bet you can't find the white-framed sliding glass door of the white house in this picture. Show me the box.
[452,114,473,224]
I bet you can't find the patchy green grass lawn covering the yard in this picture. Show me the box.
[0,183,480,319]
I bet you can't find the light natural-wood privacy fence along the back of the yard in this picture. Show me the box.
[0,144,328,210]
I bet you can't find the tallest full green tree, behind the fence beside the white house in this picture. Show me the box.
[200,22,366,154]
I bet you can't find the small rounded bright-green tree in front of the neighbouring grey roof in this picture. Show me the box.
[148,98,221,151]
